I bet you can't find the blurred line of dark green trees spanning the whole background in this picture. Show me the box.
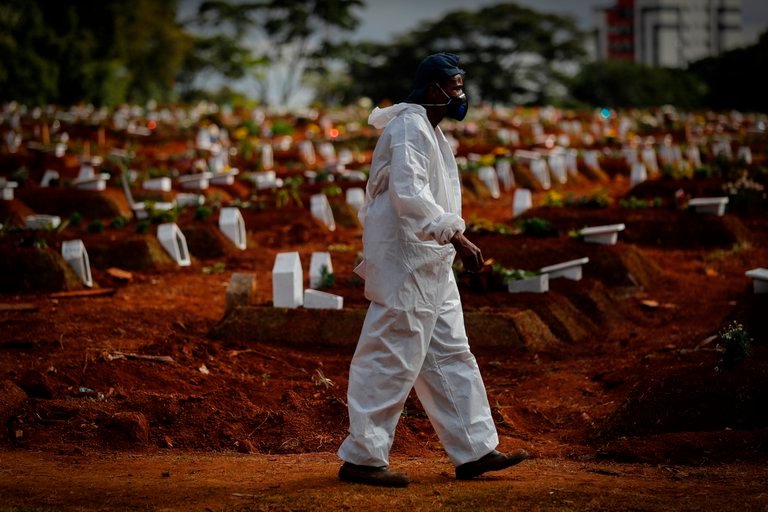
[0,0,768,112]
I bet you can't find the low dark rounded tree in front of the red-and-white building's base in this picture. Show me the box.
[571,60,706,109]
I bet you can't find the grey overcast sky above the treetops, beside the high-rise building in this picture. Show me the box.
[354,0,768,43]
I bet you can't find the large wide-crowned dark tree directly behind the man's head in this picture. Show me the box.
[314,3,585,103]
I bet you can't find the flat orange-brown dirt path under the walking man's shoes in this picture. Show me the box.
[0,451,768,511]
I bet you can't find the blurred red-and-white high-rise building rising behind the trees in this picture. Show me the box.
[595,0,743,67]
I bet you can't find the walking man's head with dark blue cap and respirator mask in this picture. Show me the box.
[405,53,468,121]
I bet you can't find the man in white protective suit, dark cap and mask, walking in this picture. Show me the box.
[338,53,528,487]
